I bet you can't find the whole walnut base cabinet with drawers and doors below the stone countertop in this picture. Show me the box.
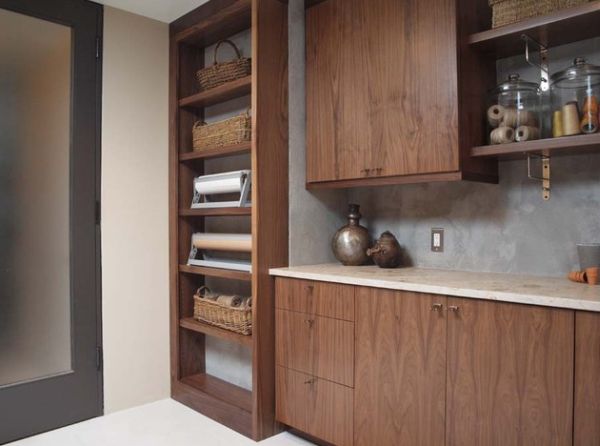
[276,278,584,446]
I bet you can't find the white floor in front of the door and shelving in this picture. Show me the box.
[7,400,312,446]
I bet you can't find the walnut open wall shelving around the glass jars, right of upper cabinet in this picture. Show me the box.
[461,0,600,159]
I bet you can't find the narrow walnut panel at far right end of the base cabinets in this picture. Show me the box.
[573,311,600,446]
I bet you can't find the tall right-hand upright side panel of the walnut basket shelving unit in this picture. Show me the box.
[251,0,288,440]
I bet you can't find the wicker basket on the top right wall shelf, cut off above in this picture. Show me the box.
[488,0,592,28]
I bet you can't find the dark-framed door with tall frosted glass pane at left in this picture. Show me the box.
[0,0,102,443]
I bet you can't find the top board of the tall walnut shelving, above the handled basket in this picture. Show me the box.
[174,0,252,48]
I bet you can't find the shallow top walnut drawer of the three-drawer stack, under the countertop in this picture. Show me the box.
[275,278,354,321]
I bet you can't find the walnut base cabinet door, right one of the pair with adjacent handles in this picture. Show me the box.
[446,298,574,446]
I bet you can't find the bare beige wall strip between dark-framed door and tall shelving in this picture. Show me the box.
[102,7,169,413]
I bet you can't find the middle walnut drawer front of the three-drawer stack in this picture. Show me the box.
[275,310,354,387]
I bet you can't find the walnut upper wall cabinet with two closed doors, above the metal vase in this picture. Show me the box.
[306,0,497,187]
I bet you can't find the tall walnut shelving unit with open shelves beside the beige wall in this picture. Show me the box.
[169,0,288,440]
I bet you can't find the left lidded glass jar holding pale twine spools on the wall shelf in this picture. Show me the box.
[487,74,542,144]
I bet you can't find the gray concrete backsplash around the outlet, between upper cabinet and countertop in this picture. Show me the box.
[349,155,600,276]
